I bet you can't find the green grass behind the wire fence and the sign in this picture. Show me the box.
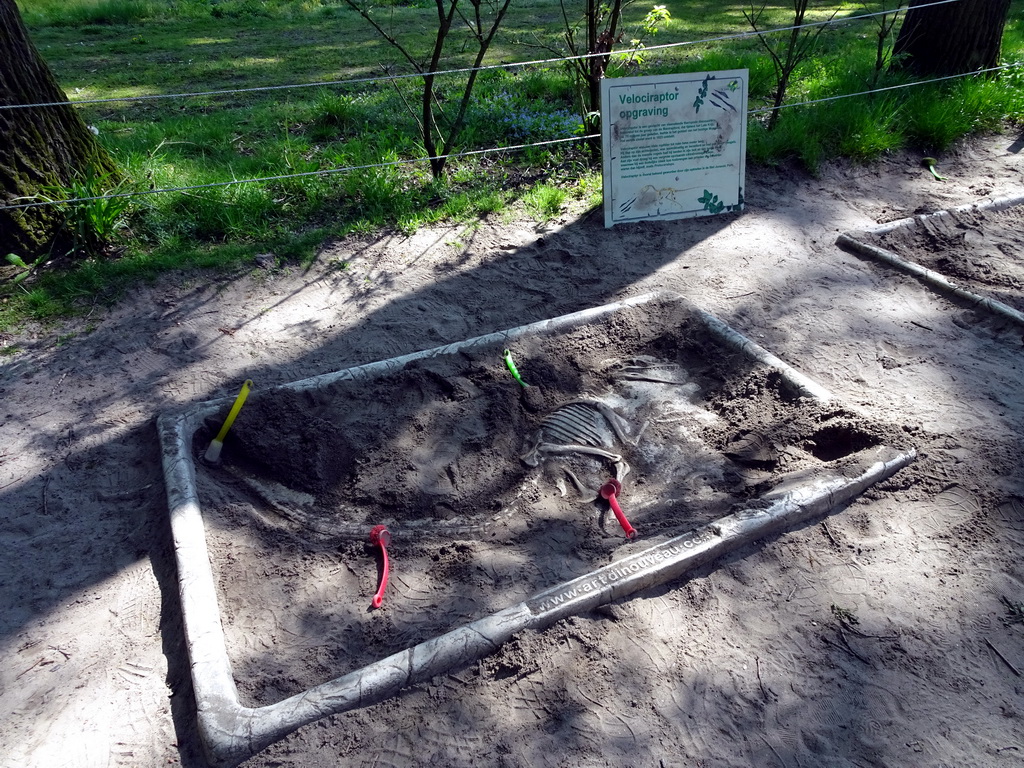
[0,0,1024,328]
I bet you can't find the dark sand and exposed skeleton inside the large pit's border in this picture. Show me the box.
[196,298,908,706]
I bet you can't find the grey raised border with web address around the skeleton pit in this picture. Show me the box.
[158,293,915,767]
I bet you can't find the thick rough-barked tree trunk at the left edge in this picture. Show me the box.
[0,0,115,260]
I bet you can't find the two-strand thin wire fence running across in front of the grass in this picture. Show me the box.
[0,0,1024,210]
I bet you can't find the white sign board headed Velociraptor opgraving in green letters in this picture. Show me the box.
[601,70,749,226]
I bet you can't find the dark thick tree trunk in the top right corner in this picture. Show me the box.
[893,0,1010,76]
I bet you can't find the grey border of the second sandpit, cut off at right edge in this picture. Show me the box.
[836,196,1024,327]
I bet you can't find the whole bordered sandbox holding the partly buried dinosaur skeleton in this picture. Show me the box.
[159,294,914,765]
